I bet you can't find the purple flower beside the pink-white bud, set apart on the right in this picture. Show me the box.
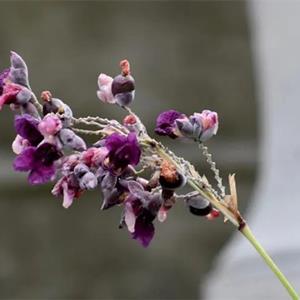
[155,109,186,139]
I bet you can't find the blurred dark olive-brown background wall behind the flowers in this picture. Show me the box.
[0,1,257,299]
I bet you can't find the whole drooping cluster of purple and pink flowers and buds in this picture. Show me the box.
[0,52,223,247]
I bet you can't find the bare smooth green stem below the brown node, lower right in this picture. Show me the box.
[240,225,299,300]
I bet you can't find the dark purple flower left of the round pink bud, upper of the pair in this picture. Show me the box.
[15,114,44,146]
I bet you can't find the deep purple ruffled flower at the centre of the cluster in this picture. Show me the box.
[105,133,141,174]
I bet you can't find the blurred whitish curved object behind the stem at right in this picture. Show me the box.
[203,1,300,300]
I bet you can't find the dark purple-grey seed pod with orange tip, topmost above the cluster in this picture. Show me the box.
[111,59,135,106]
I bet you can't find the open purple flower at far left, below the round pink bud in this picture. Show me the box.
[13,143,62,184]
